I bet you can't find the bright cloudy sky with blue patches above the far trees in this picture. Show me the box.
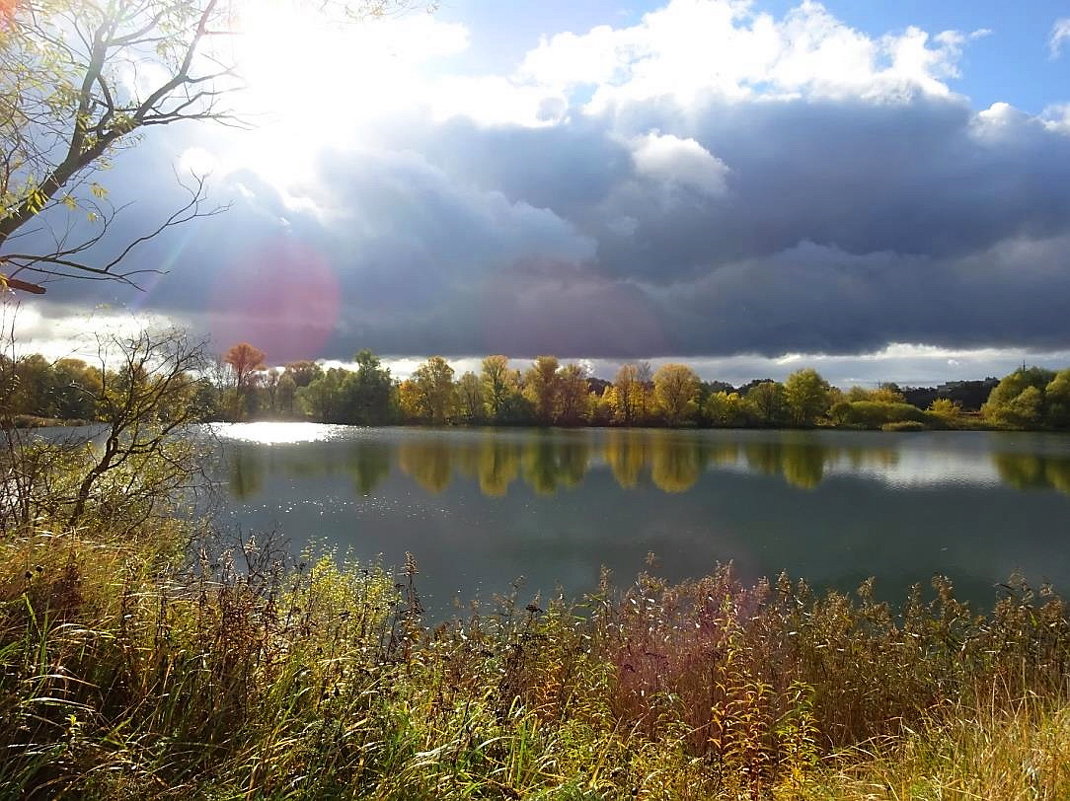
[12,0,1070,384]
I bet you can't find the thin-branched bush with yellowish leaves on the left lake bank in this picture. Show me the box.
[0,329,212,528]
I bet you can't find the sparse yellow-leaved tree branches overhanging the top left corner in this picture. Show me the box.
[0,0,238,280]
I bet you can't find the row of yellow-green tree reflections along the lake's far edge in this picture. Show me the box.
[226,429,1070,500]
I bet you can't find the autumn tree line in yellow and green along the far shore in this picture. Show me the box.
[8,342,1070,430]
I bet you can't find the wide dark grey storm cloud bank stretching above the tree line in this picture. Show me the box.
[27,77,1070,358]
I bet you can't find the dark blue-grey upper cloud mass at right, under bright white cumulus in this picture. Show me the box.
[600,98,1070,280]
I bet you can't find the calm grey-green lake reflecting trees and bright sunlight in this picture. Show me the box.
[204,423,1070,611]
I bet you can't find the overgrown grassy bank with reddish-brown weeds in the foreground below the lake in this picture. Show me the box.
[0,509,1070,799]
